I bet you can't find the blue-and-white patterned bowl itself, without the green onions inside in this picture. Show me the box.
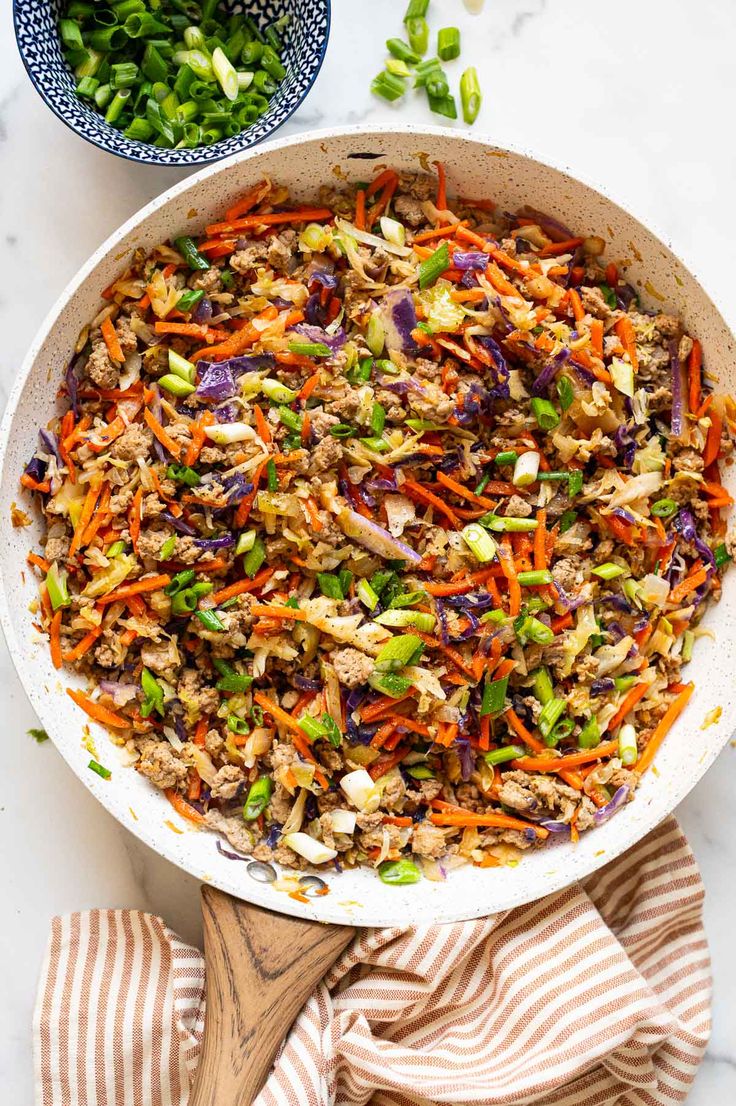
[13,0,330,166]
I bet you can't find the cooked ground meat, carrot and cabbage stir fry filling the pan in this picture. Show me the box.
[21,165,735,884]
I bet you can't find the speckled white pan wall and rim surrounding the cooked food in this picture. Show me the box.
[0,127,736,926]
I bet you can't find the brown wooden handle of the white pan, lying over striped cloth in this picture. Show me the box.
[188,887,355,1106]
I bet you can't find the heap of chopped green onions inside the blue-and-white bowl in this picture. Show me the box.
[59,0,289,149]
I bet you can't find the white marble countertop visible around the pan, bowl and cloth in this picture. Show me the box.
[0,0,736,1106]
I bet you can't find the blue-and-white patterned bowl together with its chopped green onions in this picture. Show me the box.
[13,0,330,166]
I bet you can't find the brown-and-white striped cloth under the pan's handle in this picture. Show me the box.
[34,818,711,1106]
